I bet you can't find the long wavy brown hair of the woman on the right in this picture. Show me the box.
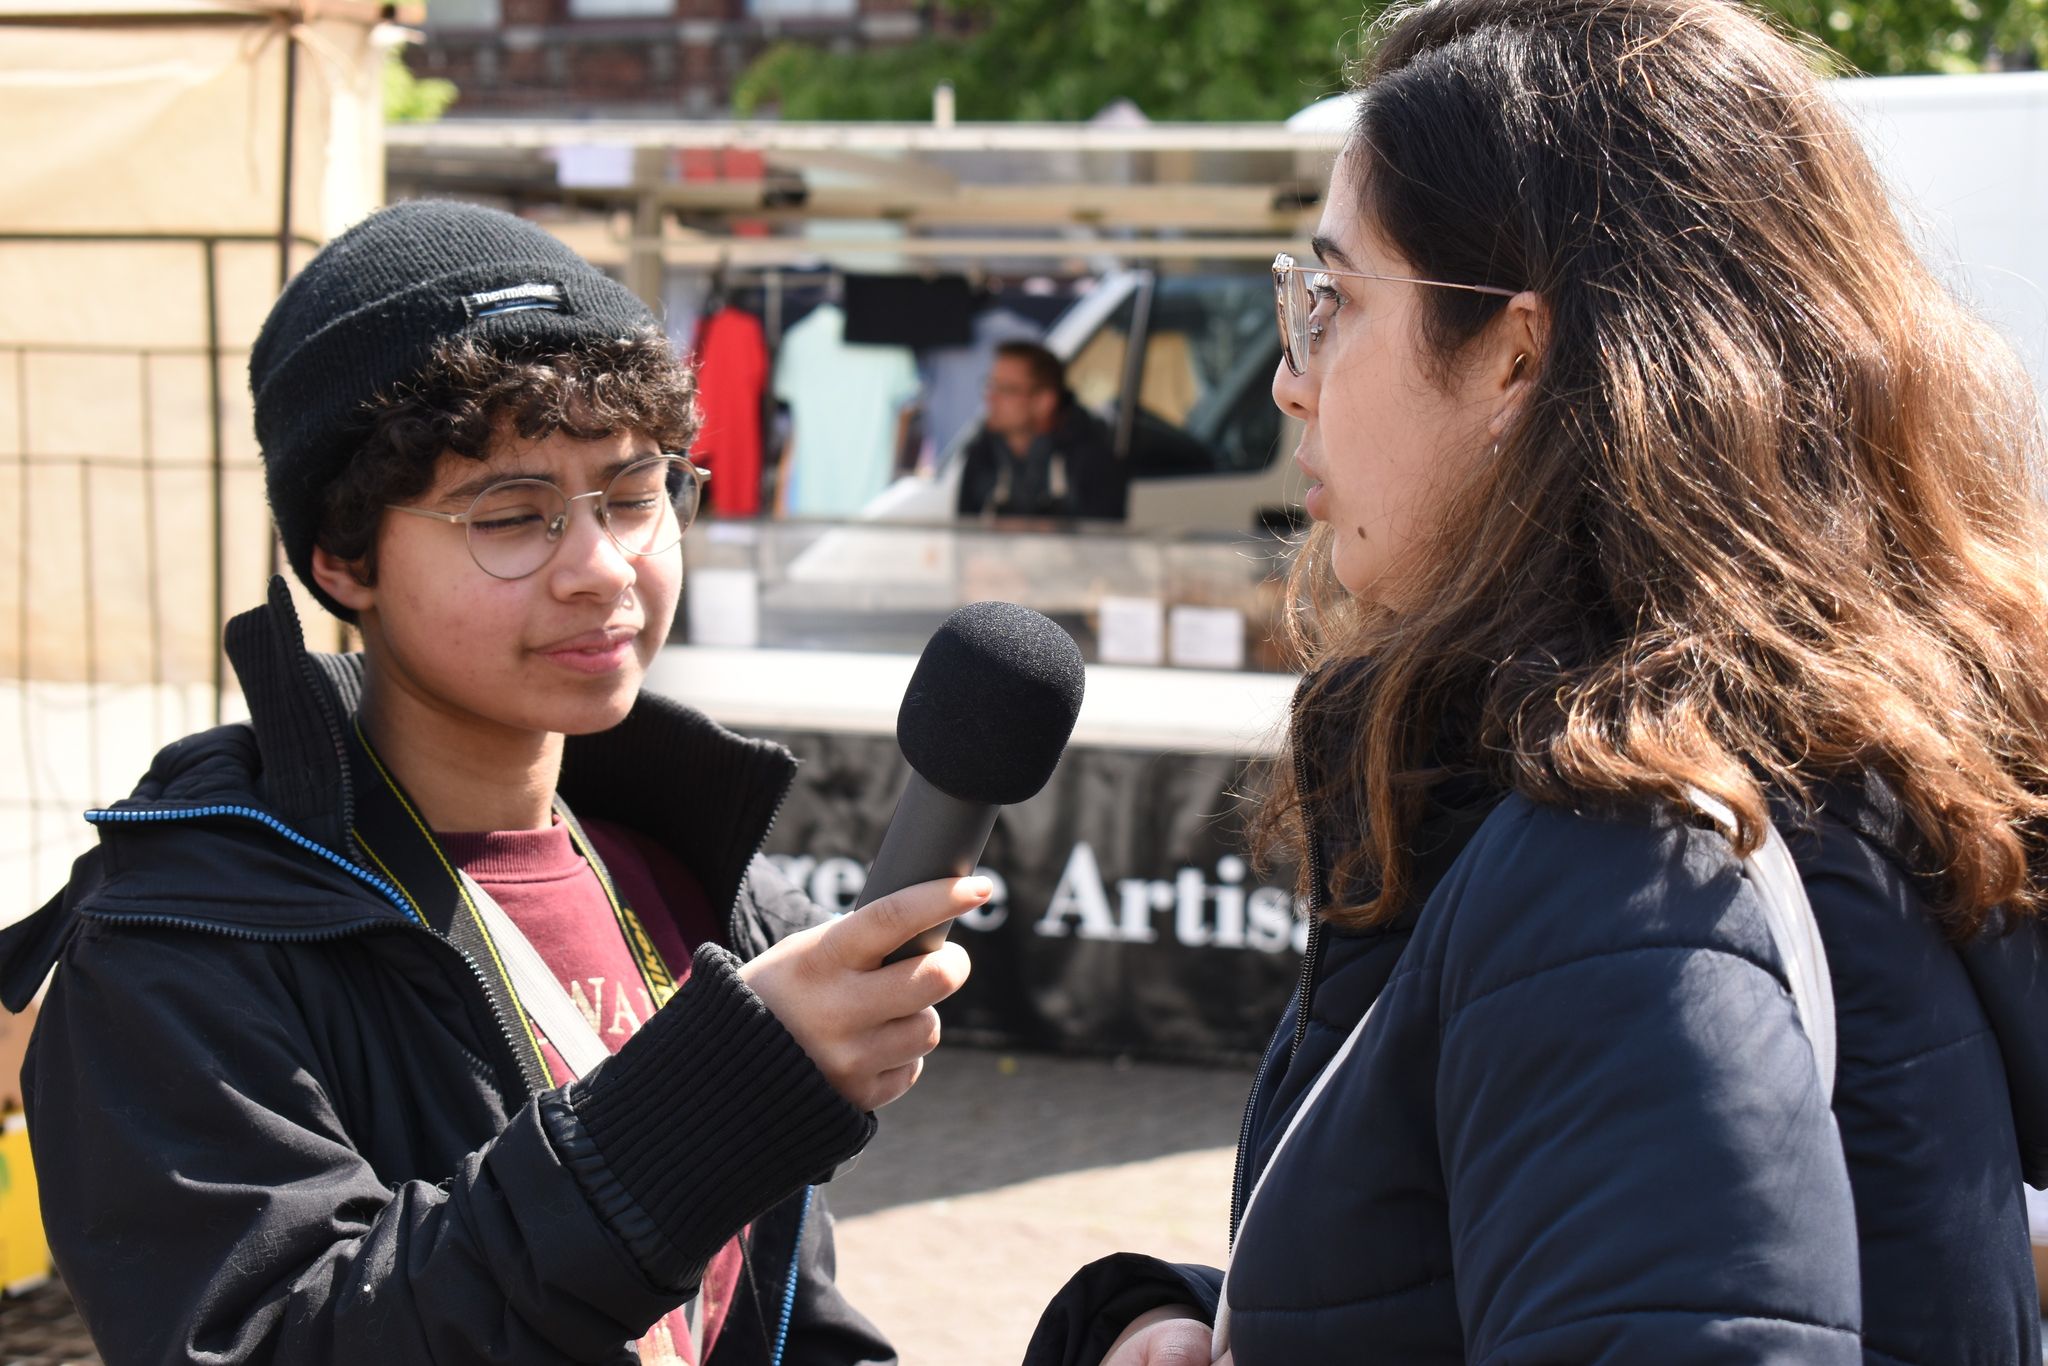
[1257,0,2048,936]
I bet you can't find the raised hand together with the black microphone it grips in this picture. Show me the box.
[739,602,1085,1110]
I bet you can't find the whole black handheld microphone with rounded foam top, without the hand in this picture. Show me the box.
[854,602,1085,963]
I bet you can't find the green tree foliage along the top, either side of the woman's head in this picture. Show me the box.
[733,0,2048,121]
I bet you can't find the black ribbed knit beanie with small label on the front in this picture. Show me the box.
[250,199,653,621]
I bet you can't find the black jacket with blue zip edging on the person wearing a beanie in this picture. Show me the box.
[0,582,893,1366]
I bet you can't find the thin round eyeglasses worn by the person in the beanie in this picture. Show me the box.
[385,455,711,580]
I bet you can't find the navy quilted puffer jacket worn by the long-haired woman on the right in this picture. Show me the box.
[1028,784,2048,1366]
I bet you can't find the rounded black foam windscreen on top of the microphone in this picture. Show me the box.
[897,602,1087,807]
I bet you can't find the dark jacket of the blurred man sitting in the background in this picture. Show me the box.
[956,397,1130,520]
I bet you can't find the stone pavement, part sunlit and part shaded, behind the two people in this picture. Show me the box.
[0,1047,1251,1366]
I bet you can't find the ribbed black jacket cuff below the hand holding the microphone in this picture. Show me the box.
[543,944,874,1288]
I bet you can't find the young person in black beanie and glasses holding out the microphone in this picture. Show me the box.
[0,203,989,1366]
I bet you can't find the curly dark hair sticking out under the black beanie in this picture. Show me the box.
[317,328,698,584]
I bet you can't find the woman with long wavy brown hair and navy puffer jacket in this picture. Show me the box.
[1032,0,2048,1366]
